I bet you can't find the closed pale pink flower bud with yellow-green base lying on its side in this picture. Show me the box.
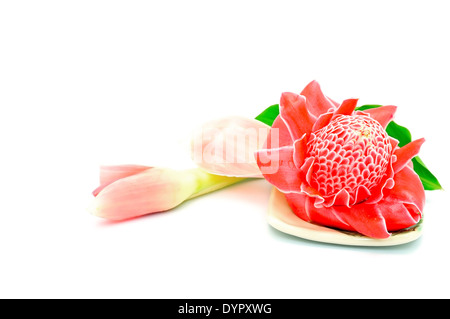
[89,165,242,220]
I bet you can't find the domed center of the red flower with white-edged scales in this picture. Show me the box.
[307,115,392,198]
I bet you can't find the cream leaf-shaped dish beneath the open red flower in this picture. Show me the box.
[268,188,422,246]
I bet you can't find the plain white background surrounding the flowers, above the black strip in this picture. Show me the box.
[0,0,450,298]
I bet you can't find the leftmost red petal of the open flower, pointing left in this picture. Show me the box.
[255,146,301,193]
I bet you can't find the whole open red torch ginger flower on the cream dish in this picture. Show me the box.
[256,81,425,238]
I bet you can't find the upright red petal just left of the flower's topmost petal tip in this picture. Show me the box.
[280,92,314,141]
